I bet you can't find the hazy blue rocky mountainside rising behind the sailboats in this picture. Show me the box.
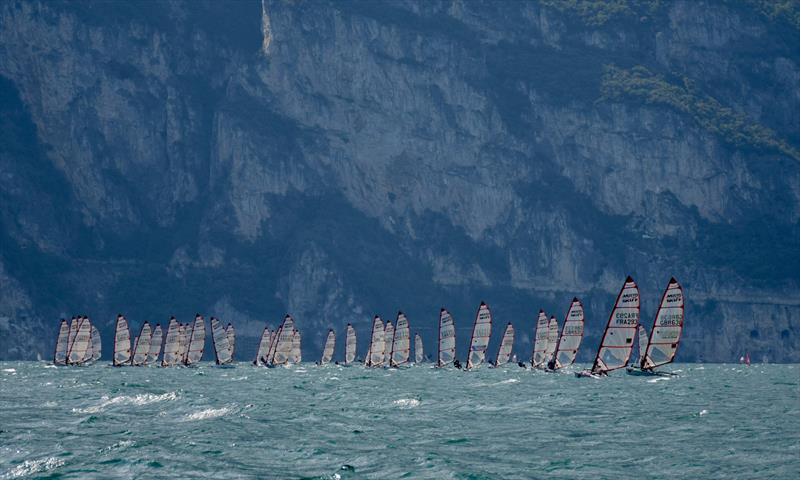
[0,0,800,361]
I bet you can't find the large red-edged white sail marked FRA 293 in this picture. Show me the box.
[592,277,639,374]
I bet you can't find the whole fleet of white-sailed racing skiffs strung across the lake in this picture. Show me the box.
[53,277,684,378]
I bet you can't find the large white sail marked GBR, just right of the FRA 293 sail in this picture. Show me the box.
[640,278,684,369]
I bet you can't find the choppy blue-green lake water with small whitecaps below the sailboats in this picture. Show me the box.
[0,362,800,479]
